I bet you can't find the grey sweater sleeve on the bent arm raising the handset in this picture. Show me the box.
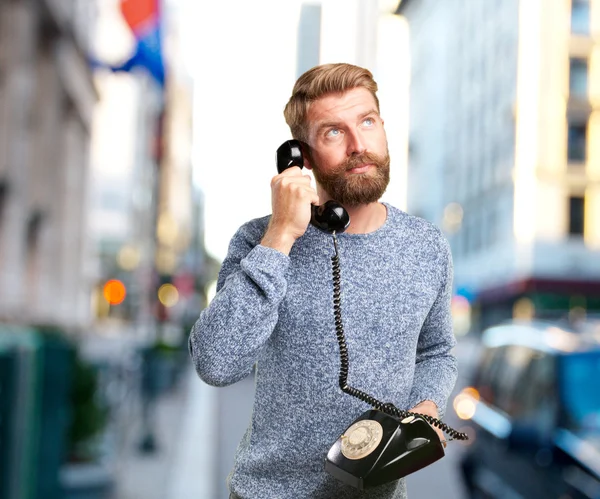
[189,224,289,386]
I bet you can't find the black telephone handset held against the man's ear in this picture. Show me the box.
[277,140,350,234]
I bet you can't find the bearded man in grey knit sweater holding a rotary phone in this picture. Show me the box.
[190,64,456,499]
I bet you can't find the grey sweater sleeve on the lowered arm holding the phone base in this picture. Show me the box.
[409,234,458,418]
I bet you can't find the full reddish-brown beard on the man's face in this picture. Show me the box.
[310,151,390,206]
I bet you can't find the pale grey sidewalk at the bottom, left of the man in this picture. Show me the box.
[115,365,217,499]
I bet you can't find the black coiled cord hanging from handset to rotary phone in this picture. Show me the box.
[331,232,469,441]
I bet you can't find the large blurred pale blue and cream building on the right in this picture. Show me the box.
[397,0,600,332]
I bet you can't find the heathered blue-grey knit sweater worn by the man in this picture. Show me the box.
[190,204,457,499]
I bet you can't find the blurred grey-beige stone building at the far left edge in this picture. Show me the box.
[0,0,97,329]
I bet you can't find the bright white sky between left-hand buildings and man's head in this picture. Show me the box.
[182,0,300,260]
